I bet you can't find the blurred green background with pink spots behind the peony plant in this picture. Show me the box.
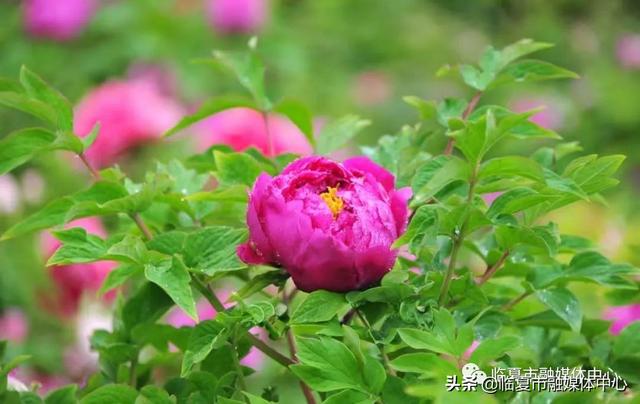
[0,0,640,398]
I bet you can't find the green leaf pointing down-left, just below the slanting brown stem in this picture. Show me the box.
[181,320,229,377]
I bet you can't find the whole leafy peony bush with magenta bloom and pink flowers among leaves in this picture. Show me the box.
[0,40,640,404]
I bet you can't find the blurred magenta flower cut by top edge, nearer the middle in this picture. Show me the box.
[205,0,269,34]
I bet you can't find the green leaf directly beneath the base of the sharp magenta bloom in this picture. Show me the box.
[291,290,348,324]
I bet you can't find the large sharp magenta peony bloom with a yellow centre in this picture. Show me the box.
[238,157,411,292]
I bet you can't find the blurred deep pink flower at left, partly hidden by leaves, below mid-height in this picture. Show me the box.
[41,217,117,316]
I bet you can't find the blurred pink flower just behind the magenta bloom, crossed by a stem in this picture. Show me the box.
[196,108,312,156]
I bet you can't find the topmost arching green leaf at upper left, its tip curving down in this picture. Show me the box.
[20,66,73,131]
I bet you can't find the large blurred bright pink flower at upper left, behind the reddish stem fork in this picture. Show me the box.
[74,79,183,167]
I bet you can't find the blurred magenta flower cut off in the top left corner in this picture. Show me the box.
[23,0,96,41]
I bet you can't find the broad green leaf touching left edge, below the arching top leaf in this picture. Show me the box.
[0,128,56,175]
